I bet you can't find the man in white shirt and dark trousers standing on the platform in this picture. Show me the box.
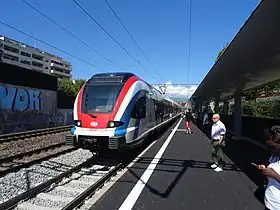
[211,114,226,172]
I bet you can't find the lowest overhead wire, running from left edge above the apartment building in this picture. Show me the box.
[0,20,106,76]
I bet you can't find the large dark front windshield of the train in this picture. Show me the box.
[82,84,123,114]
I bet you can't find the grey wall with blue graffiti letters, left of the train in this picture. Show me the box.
[0,83,58,134]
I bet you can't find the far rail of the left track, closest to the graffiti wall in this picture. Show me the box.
[0,125,72,144]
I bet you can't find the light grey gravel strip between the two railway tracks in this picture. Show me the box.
[0,149,92,204]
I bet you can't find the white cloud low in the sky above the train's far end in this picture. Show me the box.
[153,82,197,100]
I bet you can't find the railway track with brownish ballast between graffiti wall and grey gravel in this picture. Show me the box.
[0,126,74,177]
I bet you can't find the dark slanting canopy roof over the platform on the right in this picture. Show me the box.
[191,0,280,101]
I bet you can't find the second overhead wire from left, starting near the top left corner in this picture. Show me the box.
[22,0,124,70]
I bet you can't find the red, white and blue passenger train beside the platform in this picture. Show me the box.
[68,72,182,153]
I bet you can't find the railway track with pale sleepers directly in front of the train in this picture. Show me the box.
[0,157,124,210]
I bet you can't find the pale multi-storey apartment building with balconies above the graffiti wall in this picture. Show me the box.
[0,35,72,79]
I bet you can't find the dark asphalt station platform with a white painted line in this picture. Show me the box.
[91,120,264,210]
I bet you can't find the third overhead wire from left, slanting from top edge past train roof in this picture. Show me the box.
[72,0,157,81]
